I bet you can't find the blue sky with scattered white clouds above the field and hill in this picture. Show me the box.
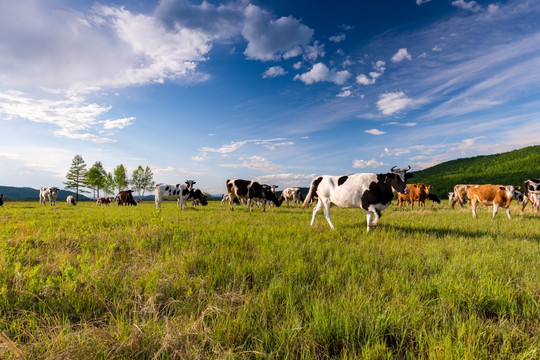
[0,0,540,194]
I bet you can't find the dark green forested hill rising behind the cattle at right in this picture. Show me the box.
[409,146,540,198]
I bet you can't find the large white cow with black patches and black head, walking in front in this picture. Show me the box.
[302,166,411,231]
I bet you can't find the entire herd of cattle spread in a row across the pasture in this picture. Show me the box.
[0,166,540,231]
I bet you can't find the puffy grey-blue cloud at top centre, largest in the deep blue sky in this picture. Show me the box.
[242,4,314,61]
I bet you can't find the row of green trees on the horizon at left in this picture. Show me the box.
[64,155,155,201]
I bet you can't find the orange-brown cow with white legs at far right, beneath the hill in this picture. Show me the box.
[467,185,519,219]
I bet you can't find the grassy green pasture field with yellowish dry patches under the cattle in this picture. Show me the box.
[0,201,540,359]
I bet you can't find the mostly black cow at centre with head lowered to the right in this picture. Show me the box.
[227,179,281,211]
